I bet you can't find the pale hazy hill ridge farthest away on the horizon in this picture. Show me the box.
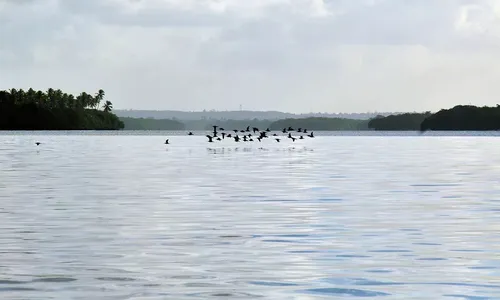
[113,109,394,121]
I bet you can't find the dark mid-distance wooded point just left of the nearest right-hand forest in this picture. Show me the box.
[368,112,431,131]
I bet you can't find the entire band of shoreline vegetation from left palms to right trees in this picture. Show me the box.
[0,88,500,131]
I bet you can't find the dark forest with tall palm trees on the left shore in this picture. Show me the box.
[0,88,123,130]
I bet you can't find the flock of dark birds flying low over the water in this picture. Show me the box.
[165,125,314,144]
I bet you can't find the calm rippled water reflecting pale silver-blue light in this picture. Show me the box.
[0,133,500,300]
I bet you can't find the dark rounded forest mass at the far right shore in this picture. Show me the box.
[420,105,500,131]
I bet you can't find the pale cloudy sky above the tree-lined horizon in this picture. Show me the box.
[0,0,500,113]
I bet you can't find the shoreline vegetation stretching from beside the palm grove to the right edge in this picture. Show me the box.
[121,105,500,131]
